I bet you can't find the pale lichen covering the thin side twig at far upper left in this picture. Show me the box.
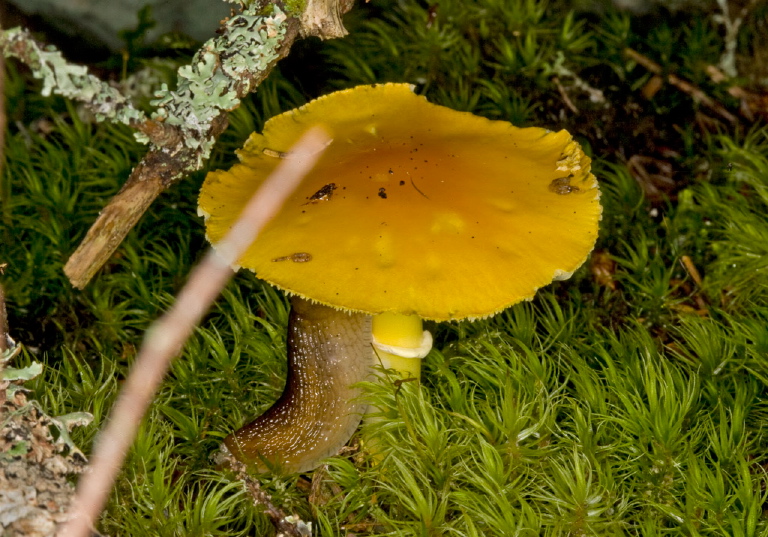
[0,28,147,125]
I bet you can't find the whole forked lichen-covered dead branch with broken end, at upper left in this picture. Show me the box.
[0,0,352,289]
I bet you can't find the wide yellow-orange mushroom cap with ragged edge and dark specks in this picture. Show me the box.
[200,84,602,320]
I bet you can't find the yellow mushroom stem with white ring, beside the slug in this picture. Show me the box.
[373,313,432,379]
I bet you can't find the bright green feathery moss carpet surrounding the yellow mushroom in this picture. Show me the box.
[0,0,768,536]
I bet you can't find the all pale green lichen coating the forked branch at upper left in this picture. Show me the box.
[0,3,288,175]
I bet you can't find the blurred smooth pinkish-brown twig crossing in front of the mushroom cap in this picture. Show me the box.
[59,128,328,537]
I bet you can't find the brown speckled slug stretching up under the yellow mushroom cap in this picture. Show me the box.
[224,297,374,473]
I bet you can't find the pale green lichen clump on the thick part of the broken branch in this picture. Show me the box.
[152,6,287,167]
